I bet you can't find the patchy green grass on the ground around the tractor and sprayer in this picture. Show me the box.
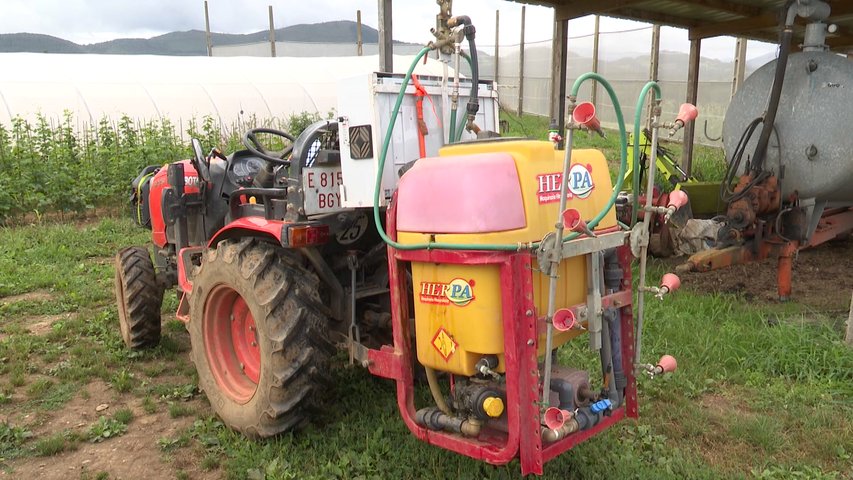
[0,197,853,479]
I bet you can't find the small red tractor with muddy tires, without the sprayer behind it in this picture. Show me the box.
[115,122,352,437]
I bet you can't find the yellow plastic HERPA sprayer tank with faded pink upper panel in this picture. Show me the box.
[397,140,616,376]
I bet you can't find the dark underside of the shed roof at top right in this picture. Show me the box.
[514,0,853,51]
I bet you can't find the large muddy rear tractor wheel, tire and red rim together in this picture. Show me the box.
[189,239,334,438]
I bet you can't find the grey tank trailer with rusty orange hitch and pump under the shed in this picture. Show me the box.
[681,0,853,299]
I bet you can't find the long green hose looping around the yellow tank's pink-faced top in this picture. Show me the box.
[373,51,628,252]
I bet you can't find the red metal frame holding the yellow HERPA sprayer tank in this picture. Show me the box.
[368,198,637,475]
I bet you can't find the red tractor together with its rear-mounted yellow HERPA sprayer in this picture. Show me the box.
[115,2,679,474]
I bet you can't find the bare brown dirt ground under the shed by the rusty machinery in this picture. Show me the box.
[667,235,853,315]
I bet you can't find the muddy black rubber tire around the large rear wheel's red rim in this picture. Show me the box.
[190,239,334,438]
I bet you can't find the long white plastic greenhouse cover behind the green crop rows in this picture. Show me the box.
[0,53,452,133]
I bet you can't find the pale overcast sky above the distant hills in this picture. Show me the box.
[0,0,774,60]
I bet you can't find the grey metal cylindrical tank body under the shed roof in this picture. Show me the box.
[723,52,853,203]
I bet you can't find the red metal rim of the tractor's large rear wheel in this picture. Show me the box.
[202,285,261,404]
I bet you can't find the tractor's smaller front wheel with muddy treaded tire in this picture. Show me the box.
[115,247,163,350]
